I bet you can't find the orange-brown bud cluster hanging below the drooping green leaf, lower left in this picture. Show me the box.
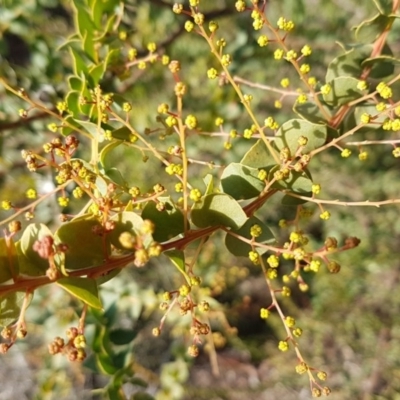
[48,327,86,361]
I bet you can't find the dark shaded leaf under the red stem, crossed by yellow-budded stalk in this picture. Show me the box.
[225,216,275,257]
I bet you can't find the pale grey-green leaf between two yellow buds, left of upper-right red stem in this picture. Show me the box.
[323,76,366,106]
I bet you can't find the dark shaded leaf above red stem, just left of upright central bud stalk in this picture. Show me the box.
[142,197,185,242]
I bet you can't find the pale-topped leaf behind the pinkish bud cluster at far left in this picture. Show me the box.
[16,224,53,276]
